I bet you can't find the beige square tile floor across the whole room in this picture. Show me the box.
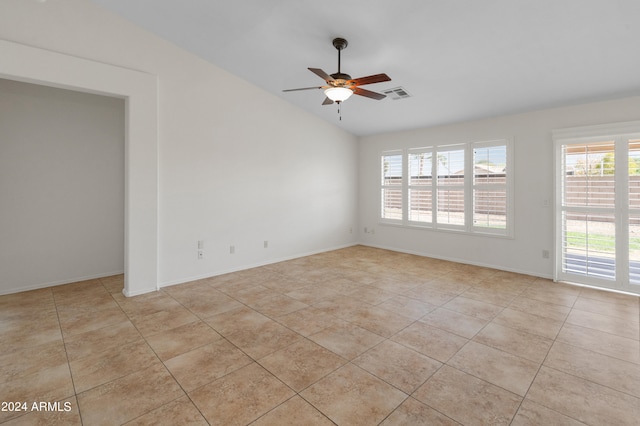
[0,246,640,426]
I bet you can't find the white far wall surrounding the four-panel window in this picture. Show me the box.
[359,97,640,278]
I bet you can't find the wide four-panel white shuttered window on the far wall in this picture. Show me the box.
[380,140,512,236]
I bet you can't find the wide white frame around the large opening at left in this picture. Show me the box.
[0,40,159,296]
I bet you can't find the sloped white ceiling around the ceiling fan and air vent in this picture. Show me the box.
[92,0,640,135]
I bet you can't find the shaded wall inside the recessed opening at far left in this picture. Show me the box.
[0,79,125,294]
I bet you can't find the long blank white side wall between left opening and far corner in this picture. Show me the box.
[0,0,358,292]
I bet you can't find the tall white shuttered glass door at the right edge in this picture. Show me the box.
[554,122,640,293]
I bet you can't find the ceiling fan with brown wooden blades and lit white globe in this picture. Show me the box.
[283,38,391,105]
